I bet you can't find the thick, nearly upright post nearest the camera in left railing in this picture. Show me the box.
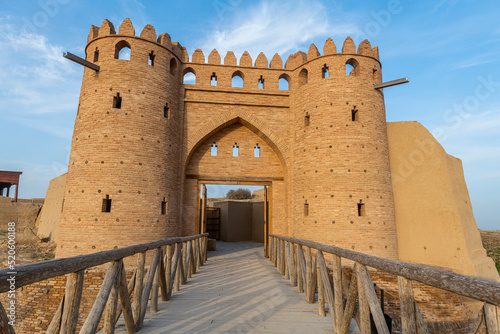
[60,270,84,334]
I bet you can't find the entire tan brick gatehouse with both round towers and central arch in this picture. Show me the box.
[56,19,398,259]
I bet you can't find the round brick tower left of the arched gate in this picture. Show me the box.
[56,19,181,257]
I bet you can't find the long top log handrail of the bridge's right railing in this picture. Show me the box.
[269,234,500,306]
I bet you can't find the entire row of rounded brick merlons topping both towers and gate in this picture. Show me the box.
[87,18,380,70]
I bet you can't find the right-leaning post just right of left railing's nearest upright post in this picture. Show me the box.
[80,260,121,334]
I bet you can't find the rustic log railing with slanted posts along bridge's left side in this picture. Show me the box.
[0,234,208,334]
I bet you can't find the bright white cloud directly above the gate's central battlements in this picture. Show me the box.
[198,0,359,61]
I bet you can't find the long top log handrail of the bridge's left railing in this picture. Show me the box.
[0,233,208,293]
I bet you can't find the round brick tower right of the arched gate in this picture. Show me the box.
[292,38,398,259]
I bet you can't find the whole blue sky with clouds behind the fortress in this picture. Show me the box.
[0,0,500,229]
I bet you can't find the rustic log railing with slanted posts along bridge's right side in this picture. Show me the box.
[269,234,500,334]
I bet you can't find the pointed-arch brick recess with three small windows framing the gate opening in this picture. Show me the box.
[182,120,286,258]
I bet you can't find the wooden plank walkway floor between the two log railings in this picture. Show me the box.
[115,242,357,334]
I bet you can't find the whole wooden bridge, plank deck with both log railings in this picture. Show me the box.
[0,234,500,334]
